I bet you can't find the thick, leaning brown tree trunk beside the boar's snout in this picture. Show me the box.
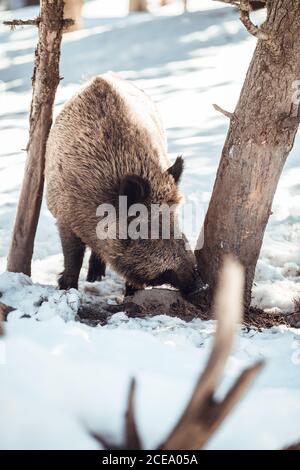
[196,0,300,303]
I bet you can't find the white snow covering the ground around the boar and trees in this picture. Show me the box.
[0,0,300,449]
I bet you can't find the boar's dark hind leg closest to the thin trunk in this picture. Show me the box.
[58,225,85,290]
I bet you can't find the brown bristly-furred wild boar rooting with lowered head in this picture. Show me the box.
[46,73,199,294]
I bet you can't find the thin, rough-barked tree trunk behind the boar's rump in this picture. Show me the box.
[7,0,64,276]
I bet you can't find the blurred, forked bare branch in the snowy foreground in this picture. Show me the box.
[92,258,263,450]
